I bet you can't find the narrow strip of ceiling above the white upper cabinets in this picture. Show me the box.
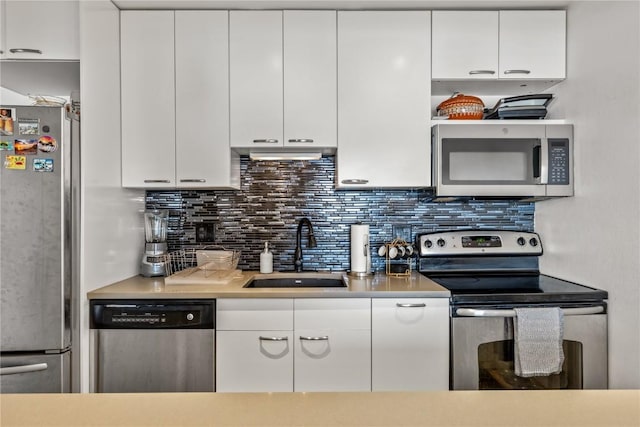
[111,0,571,10]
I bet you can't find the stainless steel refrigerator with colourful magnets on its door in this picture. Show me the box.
[0,106,79,393]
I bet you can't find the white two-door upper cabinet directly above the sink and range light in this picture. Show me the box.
[230,11,337,149]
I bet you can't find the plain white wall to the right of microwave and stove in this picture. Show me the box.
[535,1,640,388]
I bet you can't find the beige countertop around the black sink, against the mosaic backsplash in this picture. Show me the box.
[87,271,450,299]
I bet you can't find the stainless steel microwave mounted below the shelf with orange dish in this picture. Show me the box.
[431,121,573,199]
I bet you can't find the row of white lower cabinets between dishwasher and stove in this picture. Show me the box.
[216,298,449,392]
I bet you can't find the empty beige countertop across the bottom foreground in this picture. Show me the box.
[0,390,640,427]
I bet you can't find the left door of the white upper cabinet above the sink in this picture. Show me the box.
[229,10,283,148]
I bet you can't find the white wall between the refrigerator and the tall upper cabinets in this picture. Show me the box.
[75,0,144,392]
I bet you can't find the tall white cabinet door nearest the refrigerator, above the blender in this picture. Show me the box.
[119,11,176,188]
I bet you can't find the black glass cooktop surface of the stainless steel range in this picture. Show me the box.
[425,274,607,304]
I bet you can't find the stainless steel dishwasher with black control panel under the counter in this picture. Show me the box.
[90,300,215,393]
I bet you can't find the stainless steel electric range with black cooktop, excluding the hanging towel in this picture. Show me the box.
[416,230,608,390]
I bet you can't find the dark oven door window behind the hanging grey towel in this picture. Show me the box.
[478,340,582,390]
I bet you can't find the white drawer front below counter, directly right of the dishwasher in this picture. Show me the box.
[216,298,293,331]
